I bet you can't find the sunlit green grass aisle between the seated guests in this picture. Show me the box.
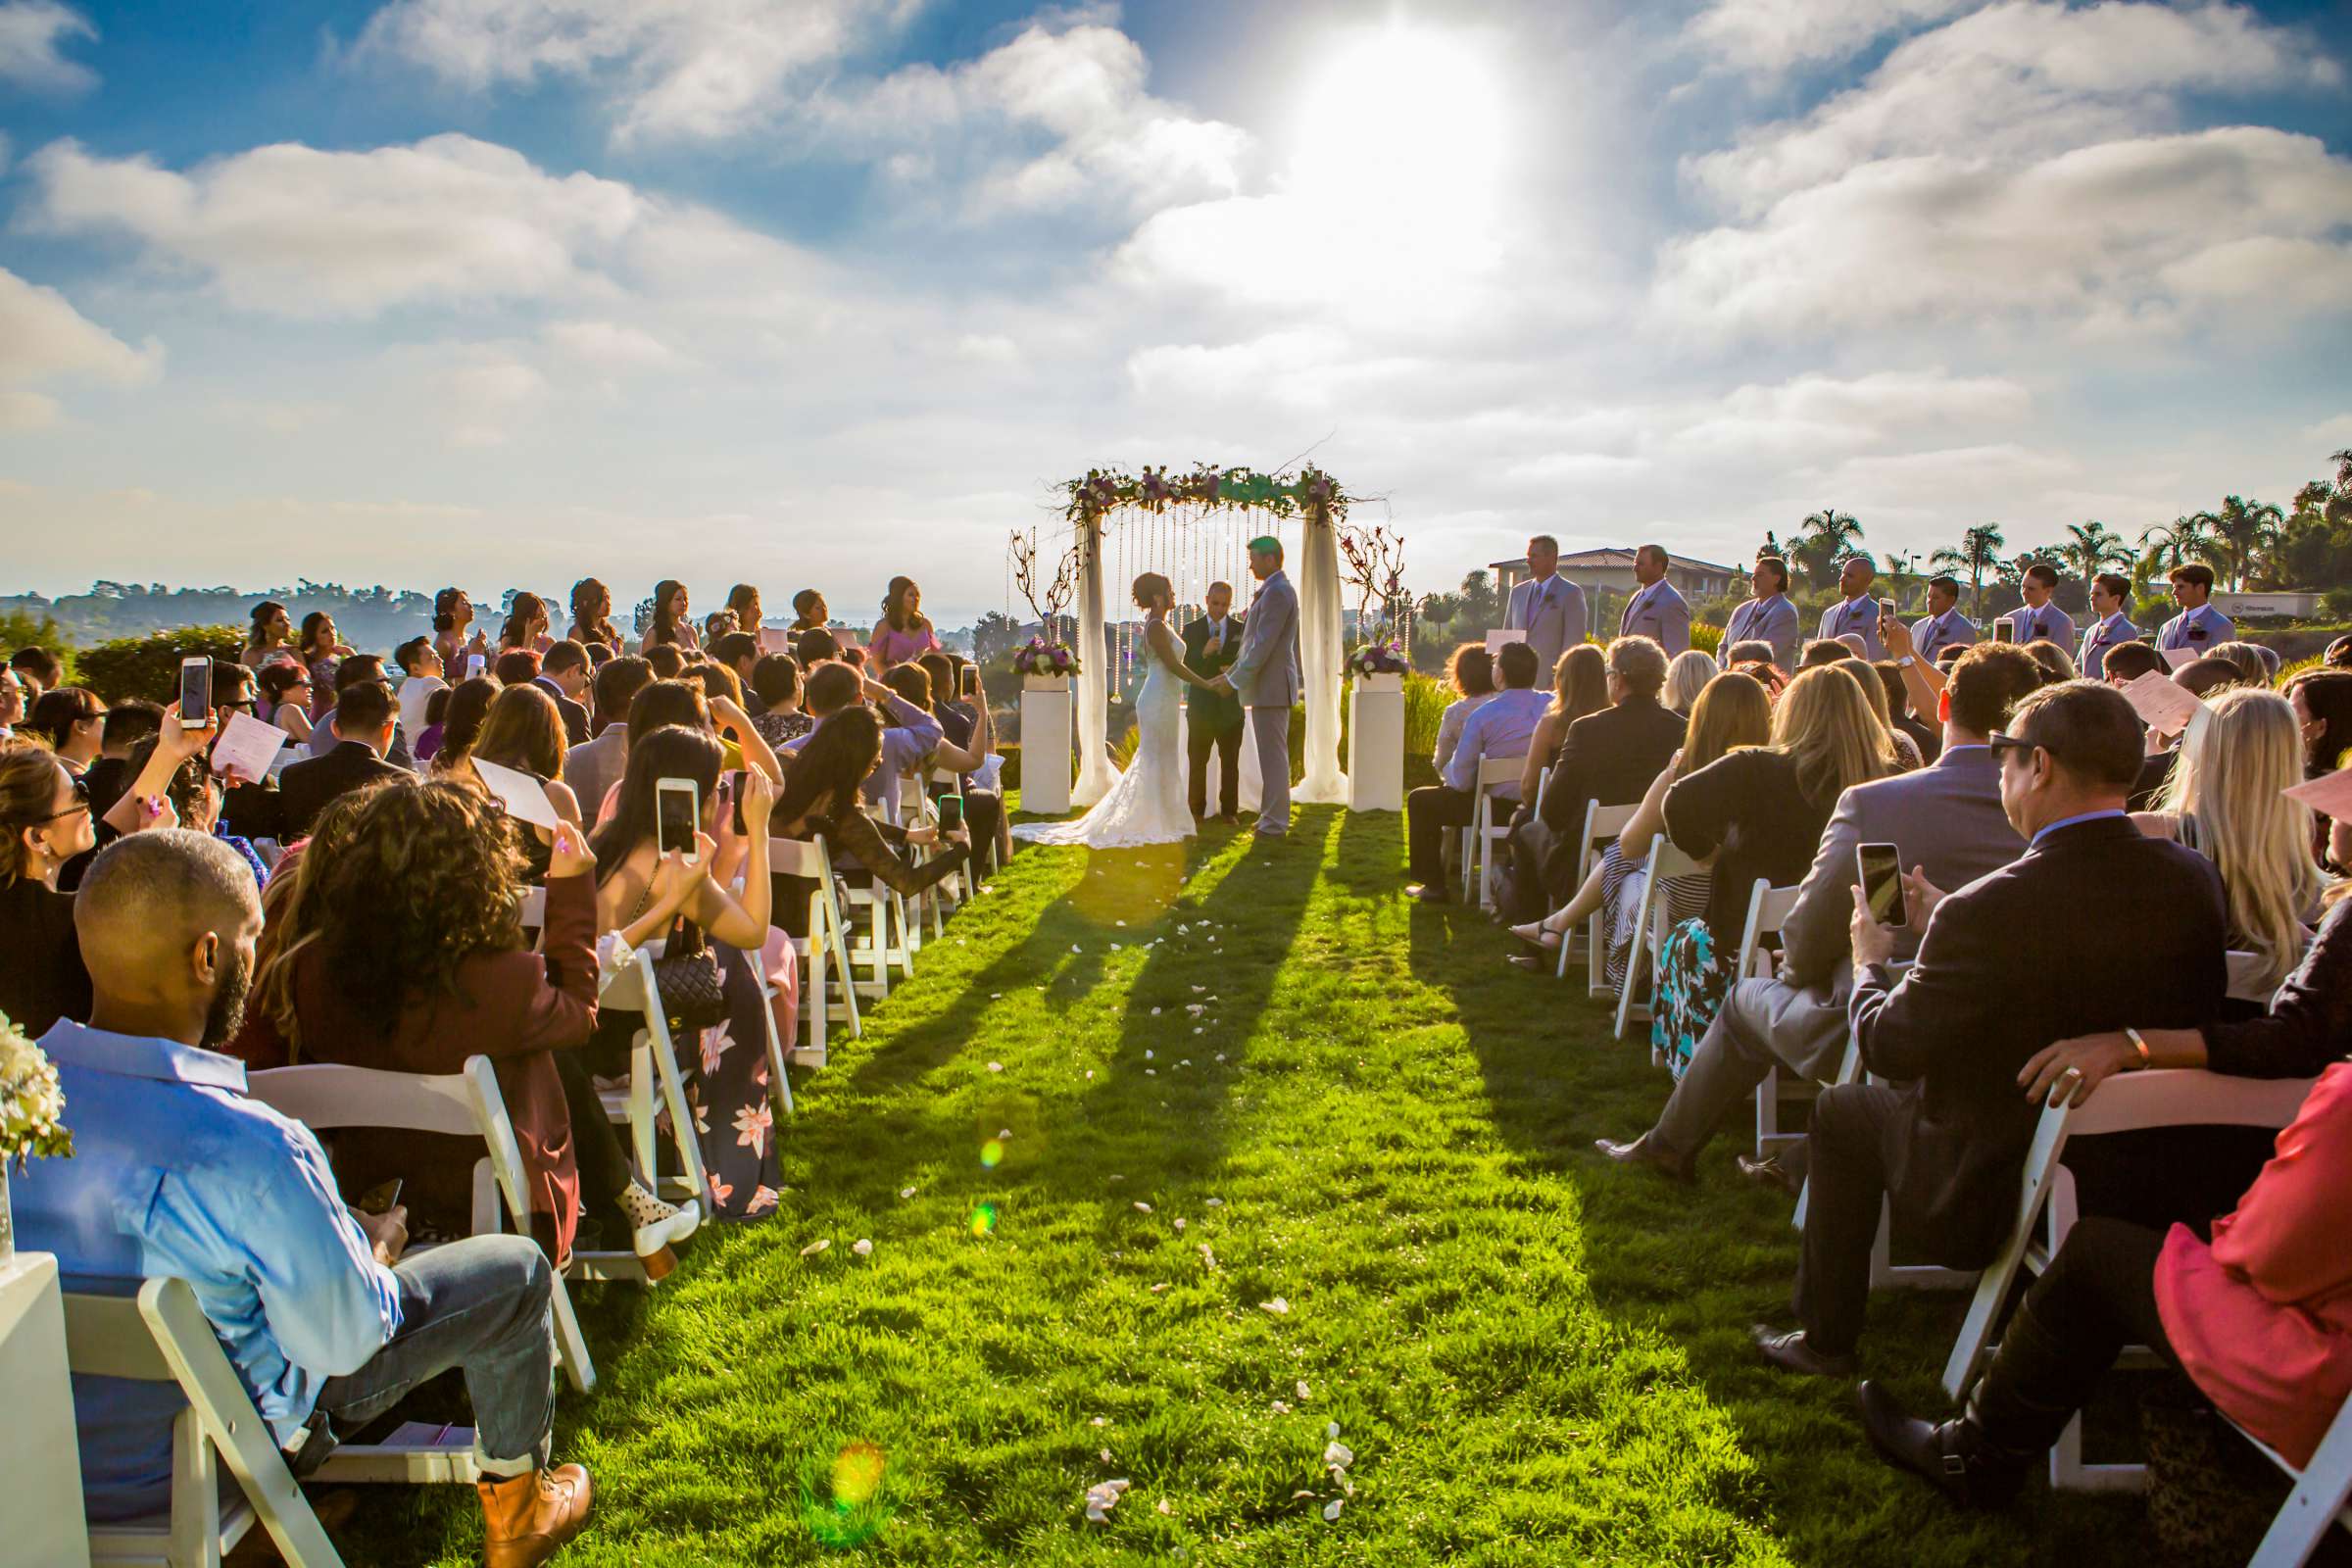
[362,808,2157,1568]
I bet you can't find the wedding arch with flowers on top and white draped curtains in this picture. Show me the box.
[1020,466,1348,808]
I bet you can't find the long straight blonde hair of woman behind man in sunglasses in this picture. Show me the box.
[2157,686,2322,990]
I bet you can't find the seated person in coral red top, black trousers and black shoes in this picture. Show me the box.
[1860,1062,2352,1507]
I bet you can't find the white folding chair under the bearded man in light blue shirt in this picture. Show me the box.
[63,1278,480,1568]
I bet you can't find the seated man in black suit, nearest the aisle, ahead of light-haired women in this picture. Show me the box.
[1503,637,1689,921]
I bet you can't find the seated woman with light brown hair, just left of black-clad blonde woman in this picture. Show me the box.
[1510,662,1776,990]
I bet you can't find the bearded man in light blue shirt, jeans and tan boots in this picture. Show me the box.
[17,830,590,1568]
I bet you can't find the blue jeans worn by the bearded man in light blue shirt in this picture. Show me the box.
[296,1237,555,1476]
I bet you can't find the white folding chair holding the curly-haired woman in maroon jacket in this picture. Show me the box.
[245,1055,597,1394]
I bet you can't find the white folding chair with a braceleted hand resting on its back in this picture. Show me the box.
[1942,1067,2317,1491]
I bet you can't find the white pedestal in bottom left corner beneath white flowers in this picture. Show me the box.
[0,1253,89,1568]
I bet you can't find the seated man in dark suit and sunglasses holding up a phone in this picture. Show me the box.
[1754,679,2228,1378]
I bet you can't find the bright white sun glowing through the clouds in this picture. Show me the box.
[1289,24,1505,223]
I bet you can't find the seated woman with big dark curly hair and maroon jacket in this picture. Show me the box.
[257,778,699,1277]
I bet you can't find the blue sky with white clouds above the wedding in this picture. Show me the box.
[0,0,2352,620]
